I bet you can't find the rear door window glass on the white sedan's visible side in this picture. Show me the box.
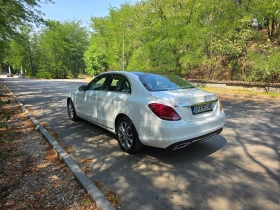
[110,74,131,93]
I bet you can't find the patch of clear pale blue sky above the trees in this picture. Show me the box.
[40,0,137,27]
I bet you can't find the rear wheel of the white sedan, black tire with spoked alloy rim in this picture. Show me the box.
[116,116,144,154]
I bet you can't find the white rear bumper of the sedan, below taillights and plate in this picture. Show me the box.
[135,111,225,149]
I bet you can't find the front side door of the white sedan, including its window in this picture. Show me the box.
[83,74,108,122]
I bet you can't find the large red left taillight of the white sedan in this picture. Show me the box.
[149,103,182,121]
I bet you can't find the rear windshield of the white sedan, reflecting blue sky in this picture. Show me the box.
[139,74,194,91]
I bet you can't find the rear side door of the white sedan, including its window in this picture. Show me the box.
[97,74,131,129]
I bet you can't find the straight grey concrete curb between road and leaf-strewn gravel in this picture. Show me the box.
[2,81,115,210]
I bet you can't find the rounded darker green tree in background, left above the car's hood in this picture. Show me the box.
[38,20,88,78]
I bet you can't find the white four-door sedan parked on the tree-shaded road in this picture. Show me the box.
[67,71,225,153]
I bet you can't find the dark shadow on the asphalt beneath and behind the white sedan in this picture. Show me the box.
[68,116,227,164]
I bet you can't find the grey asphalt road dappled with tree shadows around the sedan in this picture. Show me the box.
[1,78,280,210]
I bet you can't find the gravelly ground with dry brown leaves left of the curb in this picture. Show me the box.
[0,82,98,210]
